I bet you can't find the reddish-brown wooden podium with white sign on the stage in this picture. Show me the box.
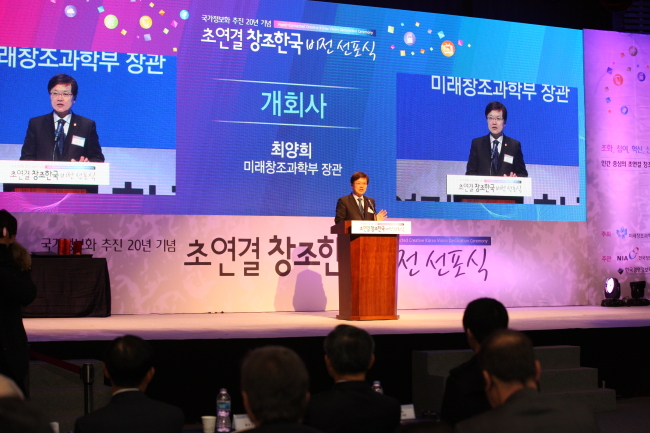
[331,221,411,320]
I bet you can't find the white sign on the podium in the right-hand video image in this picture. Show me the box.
[447,174,533,197]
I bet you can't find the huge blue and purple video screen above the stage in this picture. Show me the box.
[0,0,586,221]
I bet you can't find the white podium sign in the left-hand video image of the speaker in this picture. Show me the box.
[0,161,110,186]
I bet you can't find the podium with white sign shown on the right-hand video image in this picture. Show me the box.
[447,174,533,204]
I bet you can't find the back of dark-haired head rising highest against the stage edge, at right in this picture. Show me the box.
[463,298,508,352]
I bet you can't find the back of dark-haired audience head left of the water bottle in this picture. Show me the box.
[104,335,154,391]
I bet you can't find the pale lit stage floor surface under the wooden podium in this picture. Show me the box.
[23,306,650,342]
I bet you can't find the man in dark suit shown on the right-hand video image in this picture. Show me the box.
[465,101,528,177]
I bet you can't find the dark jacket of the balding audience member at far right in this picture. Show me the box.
[455,388,599,433]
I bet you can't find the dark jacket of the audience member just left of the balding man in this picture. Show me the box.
[440,355,491,426]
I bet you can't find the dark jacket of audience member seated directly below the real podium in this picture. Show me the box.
[304,381,402,433]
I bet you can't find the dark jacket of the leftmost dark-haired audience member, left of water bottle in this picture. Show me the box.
[74,391,185,433]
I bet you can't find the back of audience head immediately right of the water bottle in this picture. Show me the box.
[241,346,318,433]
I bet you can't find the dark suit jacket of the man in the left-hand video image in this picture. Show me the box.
[20,113,104,162]
